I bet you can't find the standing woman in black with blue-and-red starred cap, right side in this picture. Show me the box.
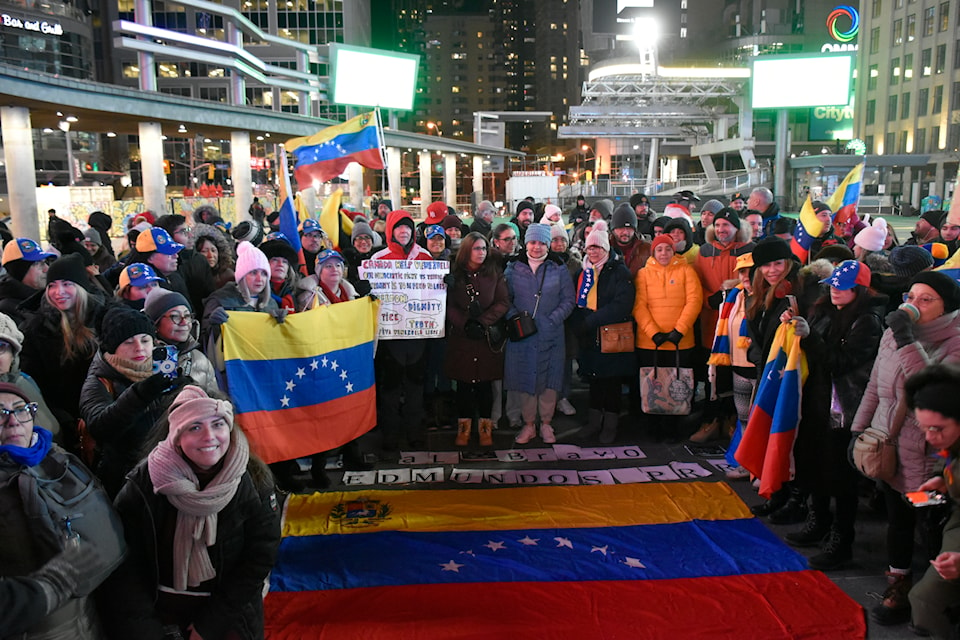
[780,260,887,571]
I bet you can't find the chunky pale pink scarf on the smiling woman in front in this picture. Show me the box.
[147,428,250,591]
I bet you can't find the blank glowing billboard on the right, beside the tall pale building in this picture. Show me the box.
[750,53,854,109]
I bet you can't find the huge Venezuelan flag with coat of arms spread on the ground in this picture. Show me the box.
[264,482,866,640]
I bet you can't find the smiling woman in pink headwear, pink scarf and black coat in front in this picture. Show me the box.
[104,385,280,640]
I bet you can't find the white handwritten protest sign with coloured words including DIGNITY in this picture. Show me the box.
[360,260,450,340]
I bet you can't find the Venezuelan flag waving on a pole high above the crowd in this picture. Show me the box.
[285,111,384,191]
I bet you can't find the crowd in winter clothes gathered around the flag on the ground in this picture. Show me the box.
[0,187,960,640]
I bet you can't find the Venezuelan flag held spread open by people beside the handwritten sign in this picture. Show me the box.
[222,298,379,462]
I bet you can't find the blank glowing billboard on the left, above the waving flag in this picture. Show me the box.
[330,43,420,111]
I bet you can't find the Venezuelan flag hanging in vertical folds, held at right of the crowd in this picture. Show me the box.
[735,323,807,497]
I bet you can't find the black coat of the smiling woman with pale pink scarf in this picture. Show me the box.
[101,461,280,640]
